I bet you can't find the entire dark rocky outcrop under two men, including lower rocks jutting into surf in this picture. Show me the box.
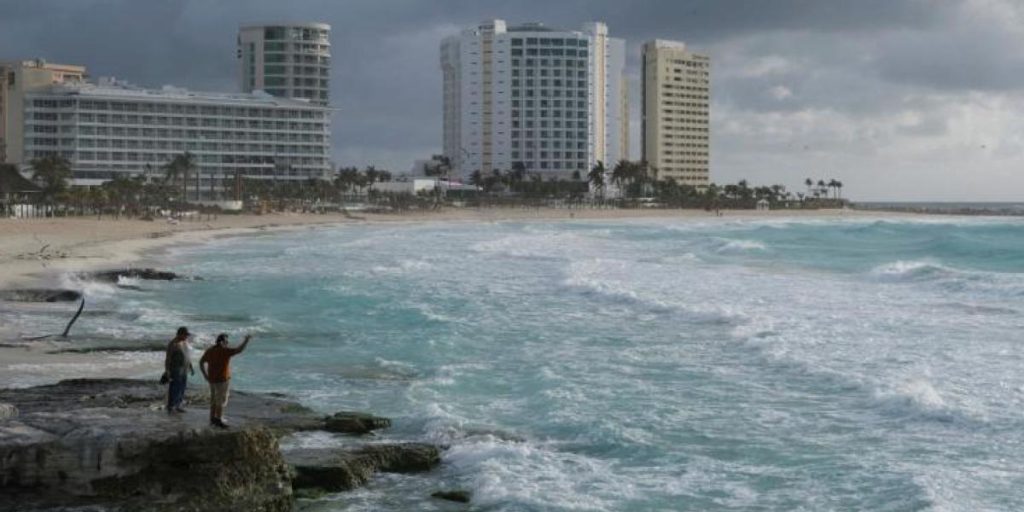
[0,379,448,512]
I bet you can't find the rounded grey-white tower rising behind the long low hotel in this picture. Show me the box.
[238,24,331,105]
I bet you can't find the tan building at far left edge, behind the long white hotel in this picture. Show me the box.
[0,59,86,163]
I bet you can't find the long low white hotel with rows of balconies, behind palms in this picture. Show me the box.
[6,75,332,193]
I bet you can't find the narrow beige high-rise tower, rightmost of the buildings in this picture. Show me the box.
[642,40,711,186]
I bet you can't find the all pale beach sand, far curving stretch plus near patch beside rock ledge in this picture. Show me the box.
[0,208,914,387]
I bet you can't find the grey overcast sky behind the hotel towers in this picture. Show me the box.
[0,0,1024,201]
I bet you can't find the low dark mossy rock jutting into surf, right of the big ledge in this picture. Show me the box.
[285,442,440,492]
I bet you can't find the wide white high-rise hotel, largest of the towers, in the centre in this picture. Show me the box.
[440,19,629,176]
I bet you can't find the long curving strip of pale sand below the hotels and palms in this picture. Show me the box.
[0,208,901,289]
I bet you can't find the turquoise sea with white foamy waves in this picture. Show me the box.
[18,218,1024,511]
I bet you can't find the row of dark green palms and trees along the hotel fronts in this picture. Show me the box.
[4,153,843,216]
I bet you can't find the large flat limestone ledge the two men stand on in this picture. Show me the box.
[0,379,323,512]
